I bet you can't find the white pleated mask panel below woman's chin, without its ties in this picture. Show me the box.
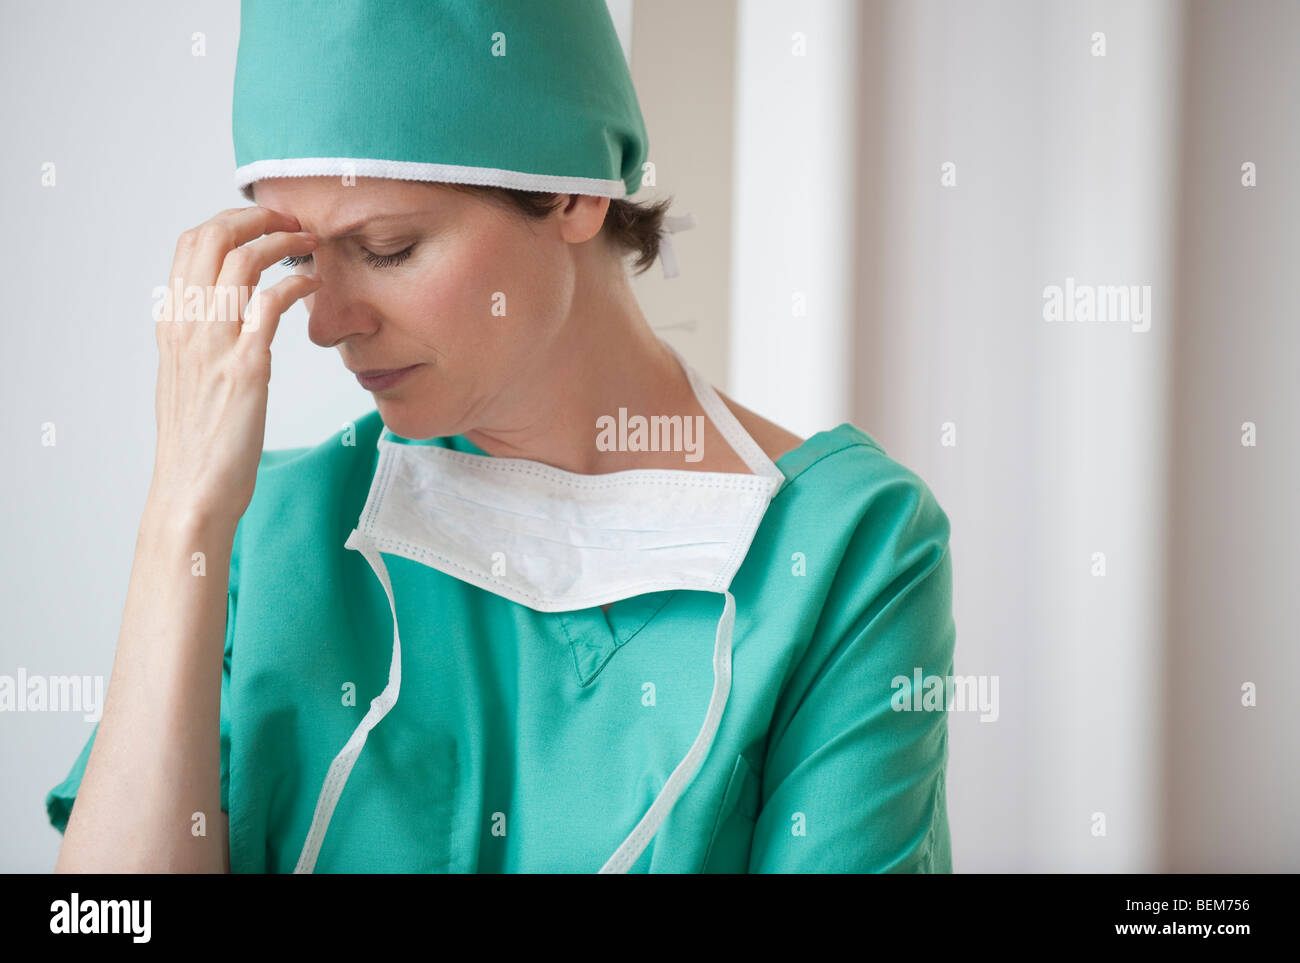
[358,428,779,612]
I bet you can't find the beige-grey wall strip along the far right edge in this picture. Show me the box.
[1165,1,1300,872]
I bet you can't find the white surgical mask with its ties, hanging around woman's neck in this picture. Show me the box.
[294,342,784,872]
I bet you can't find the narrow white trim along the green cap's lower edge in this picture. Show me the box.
[235,157,628,200]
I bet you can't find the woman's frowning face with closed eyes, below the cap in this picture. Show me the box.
[254,177,608,439]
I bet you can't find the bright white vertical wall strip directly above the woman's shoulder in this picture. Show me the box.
[729,0,861,437]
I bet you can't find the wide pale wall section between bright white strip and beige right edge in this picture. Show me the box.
[873,3,1178,872]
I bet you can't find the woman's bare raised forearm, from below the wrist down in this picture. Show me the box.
[55,498,235,872]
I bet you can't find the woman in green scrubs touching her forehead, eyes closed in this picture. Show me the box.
[47,0,954,872]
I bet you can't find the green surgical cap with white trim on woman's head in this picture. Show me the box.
[233,0,647,200]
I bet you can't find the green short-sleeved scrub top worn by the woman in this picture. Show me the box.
[46,411,956,873]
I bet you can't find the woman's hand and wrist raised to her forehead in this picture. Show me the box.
[150,207,320,525]
